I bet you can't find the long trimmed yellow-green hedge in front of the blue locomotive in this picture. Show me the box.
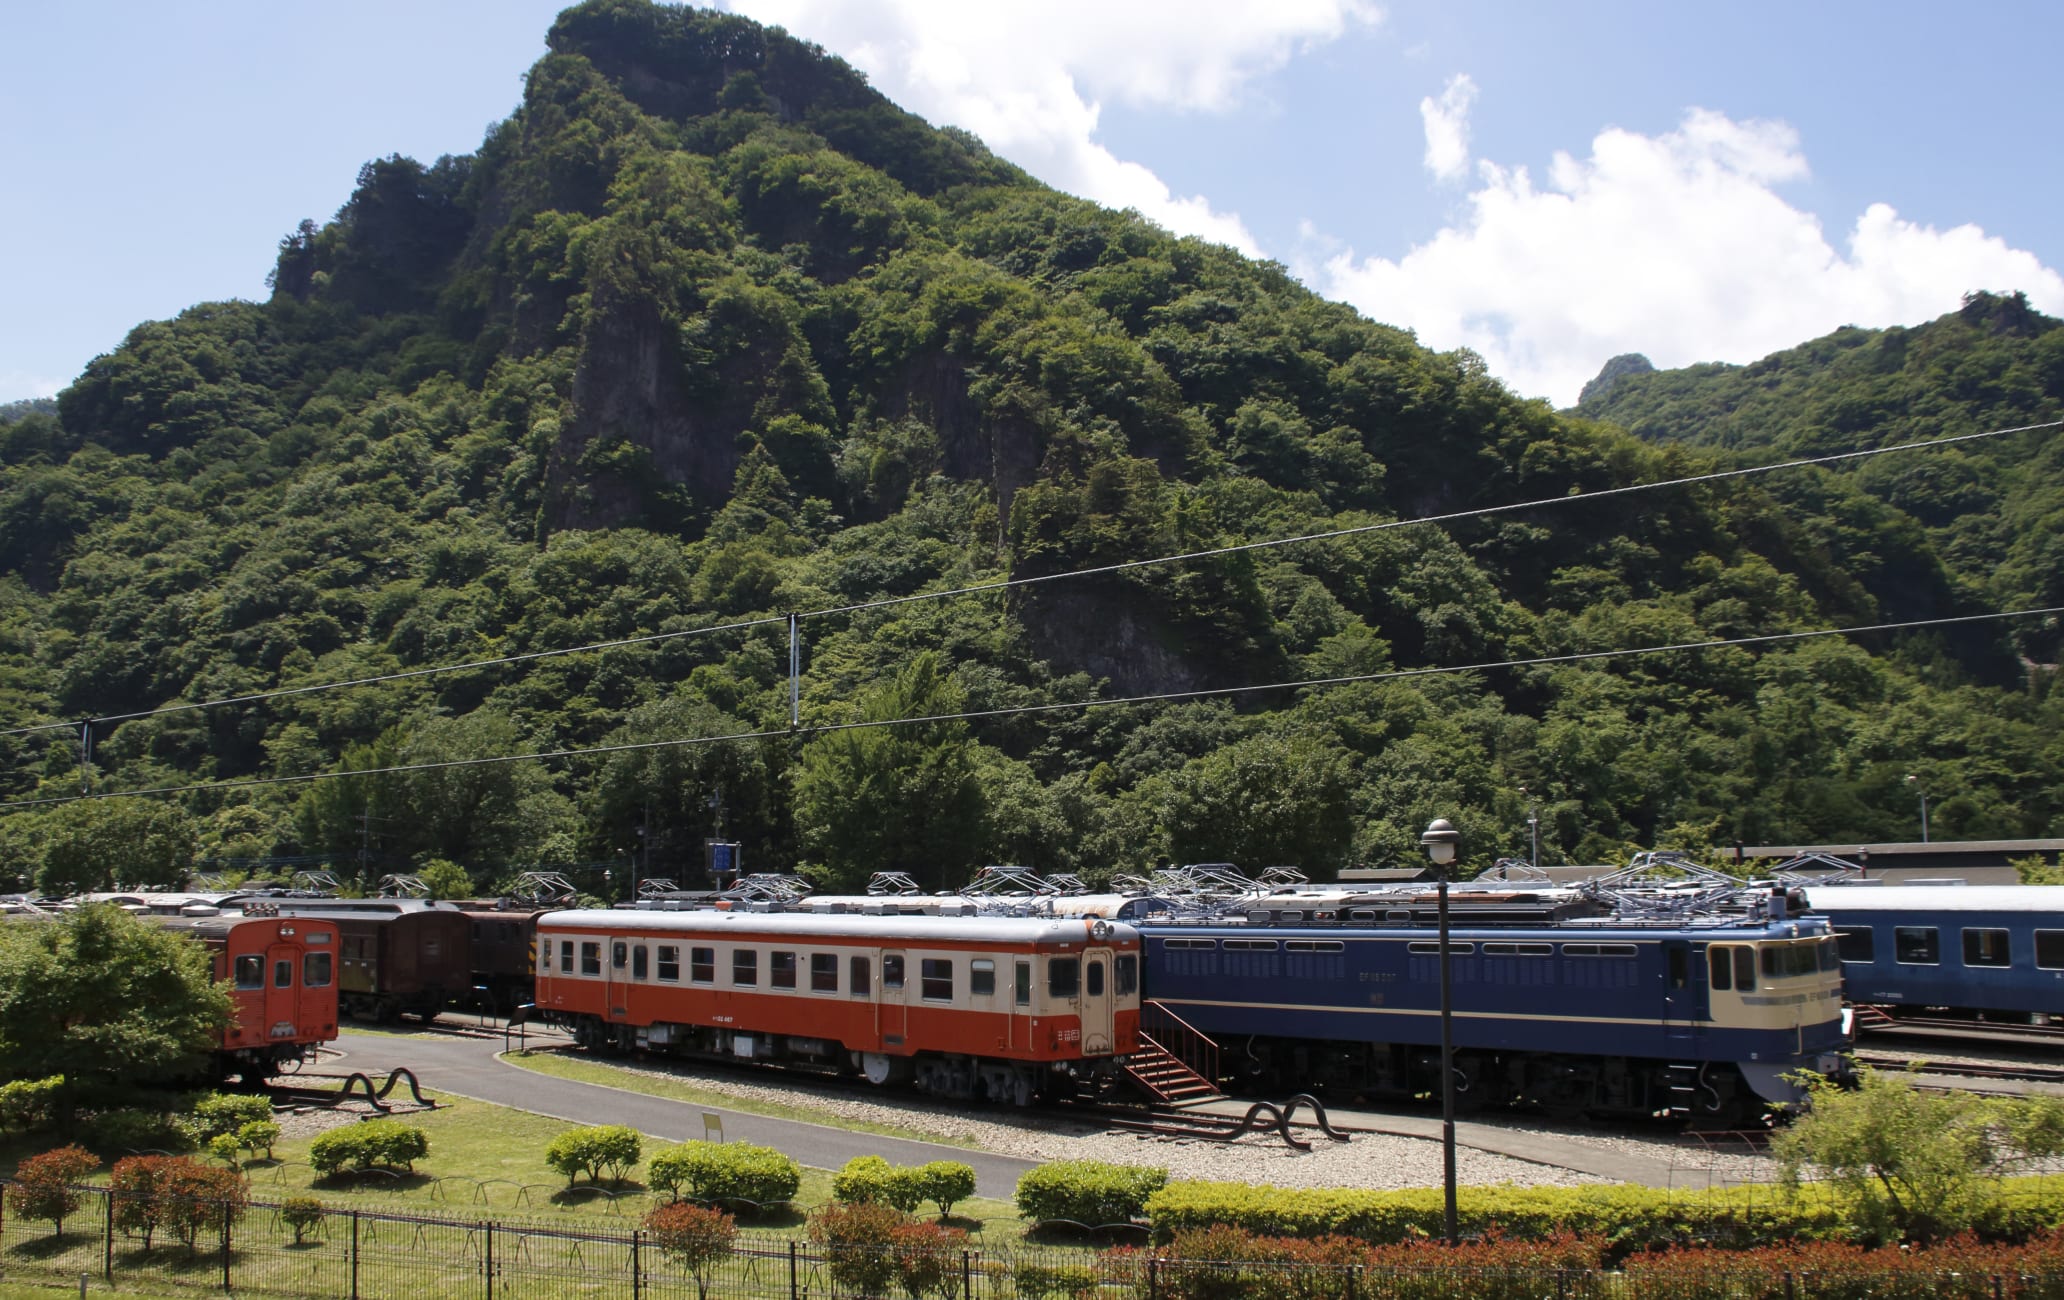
[1147,1166,2064,1253]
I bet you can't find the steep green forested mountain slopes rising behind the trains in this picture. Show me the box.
[0,0,2064,889]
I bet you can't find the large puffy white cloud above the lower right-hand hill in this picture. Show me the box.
[1315,110,2064,404]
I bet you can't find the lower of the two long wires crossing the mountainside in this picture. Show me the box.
[0,605,2064,809]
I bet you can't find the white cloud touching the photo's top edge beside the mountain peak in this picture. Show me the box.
[731,0,1379,254]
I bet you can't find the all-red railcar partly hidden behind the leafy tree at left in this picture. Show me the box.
[151,912,336,1079]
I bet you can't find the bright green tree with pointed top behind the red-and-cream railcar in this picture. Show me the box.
[795,654,987,889]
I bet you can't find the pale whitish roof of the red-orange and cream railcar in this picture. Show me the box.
[537,908,1139,943]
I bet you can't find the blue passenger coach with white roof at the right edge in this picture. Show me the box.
[1810,885,2064,1019]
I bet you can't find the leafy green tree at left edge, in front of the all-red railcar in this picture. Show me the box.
[0,906,229,1098]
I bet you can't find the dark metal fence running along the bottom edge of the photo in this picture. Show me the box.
[12,1189,2064,1300]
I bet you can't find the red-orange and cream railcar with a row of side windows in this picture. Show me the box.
[537,910,1139,1106]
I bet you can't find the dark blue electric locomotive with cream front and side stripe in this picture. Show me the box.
[1135,889,1845,1123]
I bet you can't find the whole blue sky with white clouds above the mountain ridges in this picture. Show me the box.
[0,0,2064,407]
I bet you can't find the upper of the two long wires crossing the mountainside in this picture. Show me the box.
[0,421,2064,742]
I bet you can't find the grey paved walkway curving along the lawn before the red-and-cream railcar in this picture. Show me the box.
[340,1030,1034,1201]
